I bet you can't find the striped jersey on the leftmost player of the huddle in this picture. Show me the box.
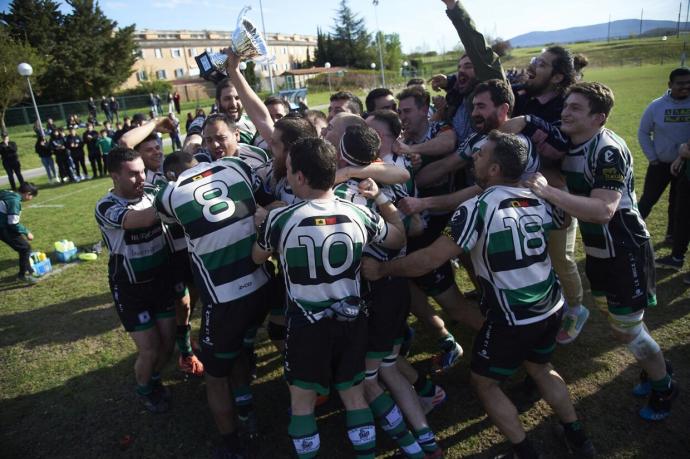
[96,192,169,284]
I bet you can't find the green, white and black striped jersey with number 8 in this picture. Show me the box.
[156,158,268,304]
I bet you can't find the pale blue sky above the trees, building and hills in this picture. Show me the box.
[0,0,676,52]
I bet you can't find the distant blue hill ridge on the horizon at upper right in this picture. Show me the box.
[510,19,687,47]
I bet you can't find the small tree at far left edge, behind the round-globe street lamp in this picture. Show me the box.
[0,28,46,131]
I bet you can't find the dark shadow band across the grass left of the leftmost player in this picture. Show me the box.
[0,292,120,348]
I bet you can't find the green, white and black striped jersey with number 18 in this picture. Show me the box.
[450,186,563,326]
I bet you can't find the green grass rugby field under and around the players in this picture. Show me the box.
[0,65,690,458]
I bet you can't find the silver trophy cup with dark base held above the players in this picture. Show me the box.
[194,6,268,83]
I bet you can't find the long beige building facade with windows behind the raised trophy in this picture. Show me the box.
[123,30,316,93]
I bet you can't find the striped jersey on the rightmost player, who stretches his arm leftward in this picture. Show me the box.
[561,128,649,258]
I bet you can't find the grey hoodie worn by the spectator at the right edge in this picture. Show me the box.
[637,91,690,163]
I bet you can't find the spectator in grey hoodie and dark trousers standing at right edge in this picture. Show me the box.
[637,68,690,243]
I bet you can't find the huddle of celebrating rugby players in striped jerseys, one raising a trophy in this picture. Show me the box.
[96,0,678,458]
